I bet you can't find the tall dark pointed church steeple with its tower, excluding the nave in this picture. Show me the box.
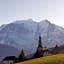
[34,36,43,58]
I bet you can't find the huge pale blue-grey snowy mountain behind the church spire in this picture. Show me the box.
[0,19,64,54]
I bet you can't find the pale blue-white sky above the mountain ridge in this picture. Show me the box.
[0,0,64,27]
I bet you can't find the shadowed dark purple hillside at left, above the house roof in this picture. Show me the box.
[0,44,20,60]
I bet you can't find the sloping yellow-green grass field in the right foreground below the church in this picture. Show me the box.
[17,54,64,64]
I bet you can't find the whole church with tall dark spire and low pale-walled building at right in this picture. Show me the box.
[34,35,49,58]
